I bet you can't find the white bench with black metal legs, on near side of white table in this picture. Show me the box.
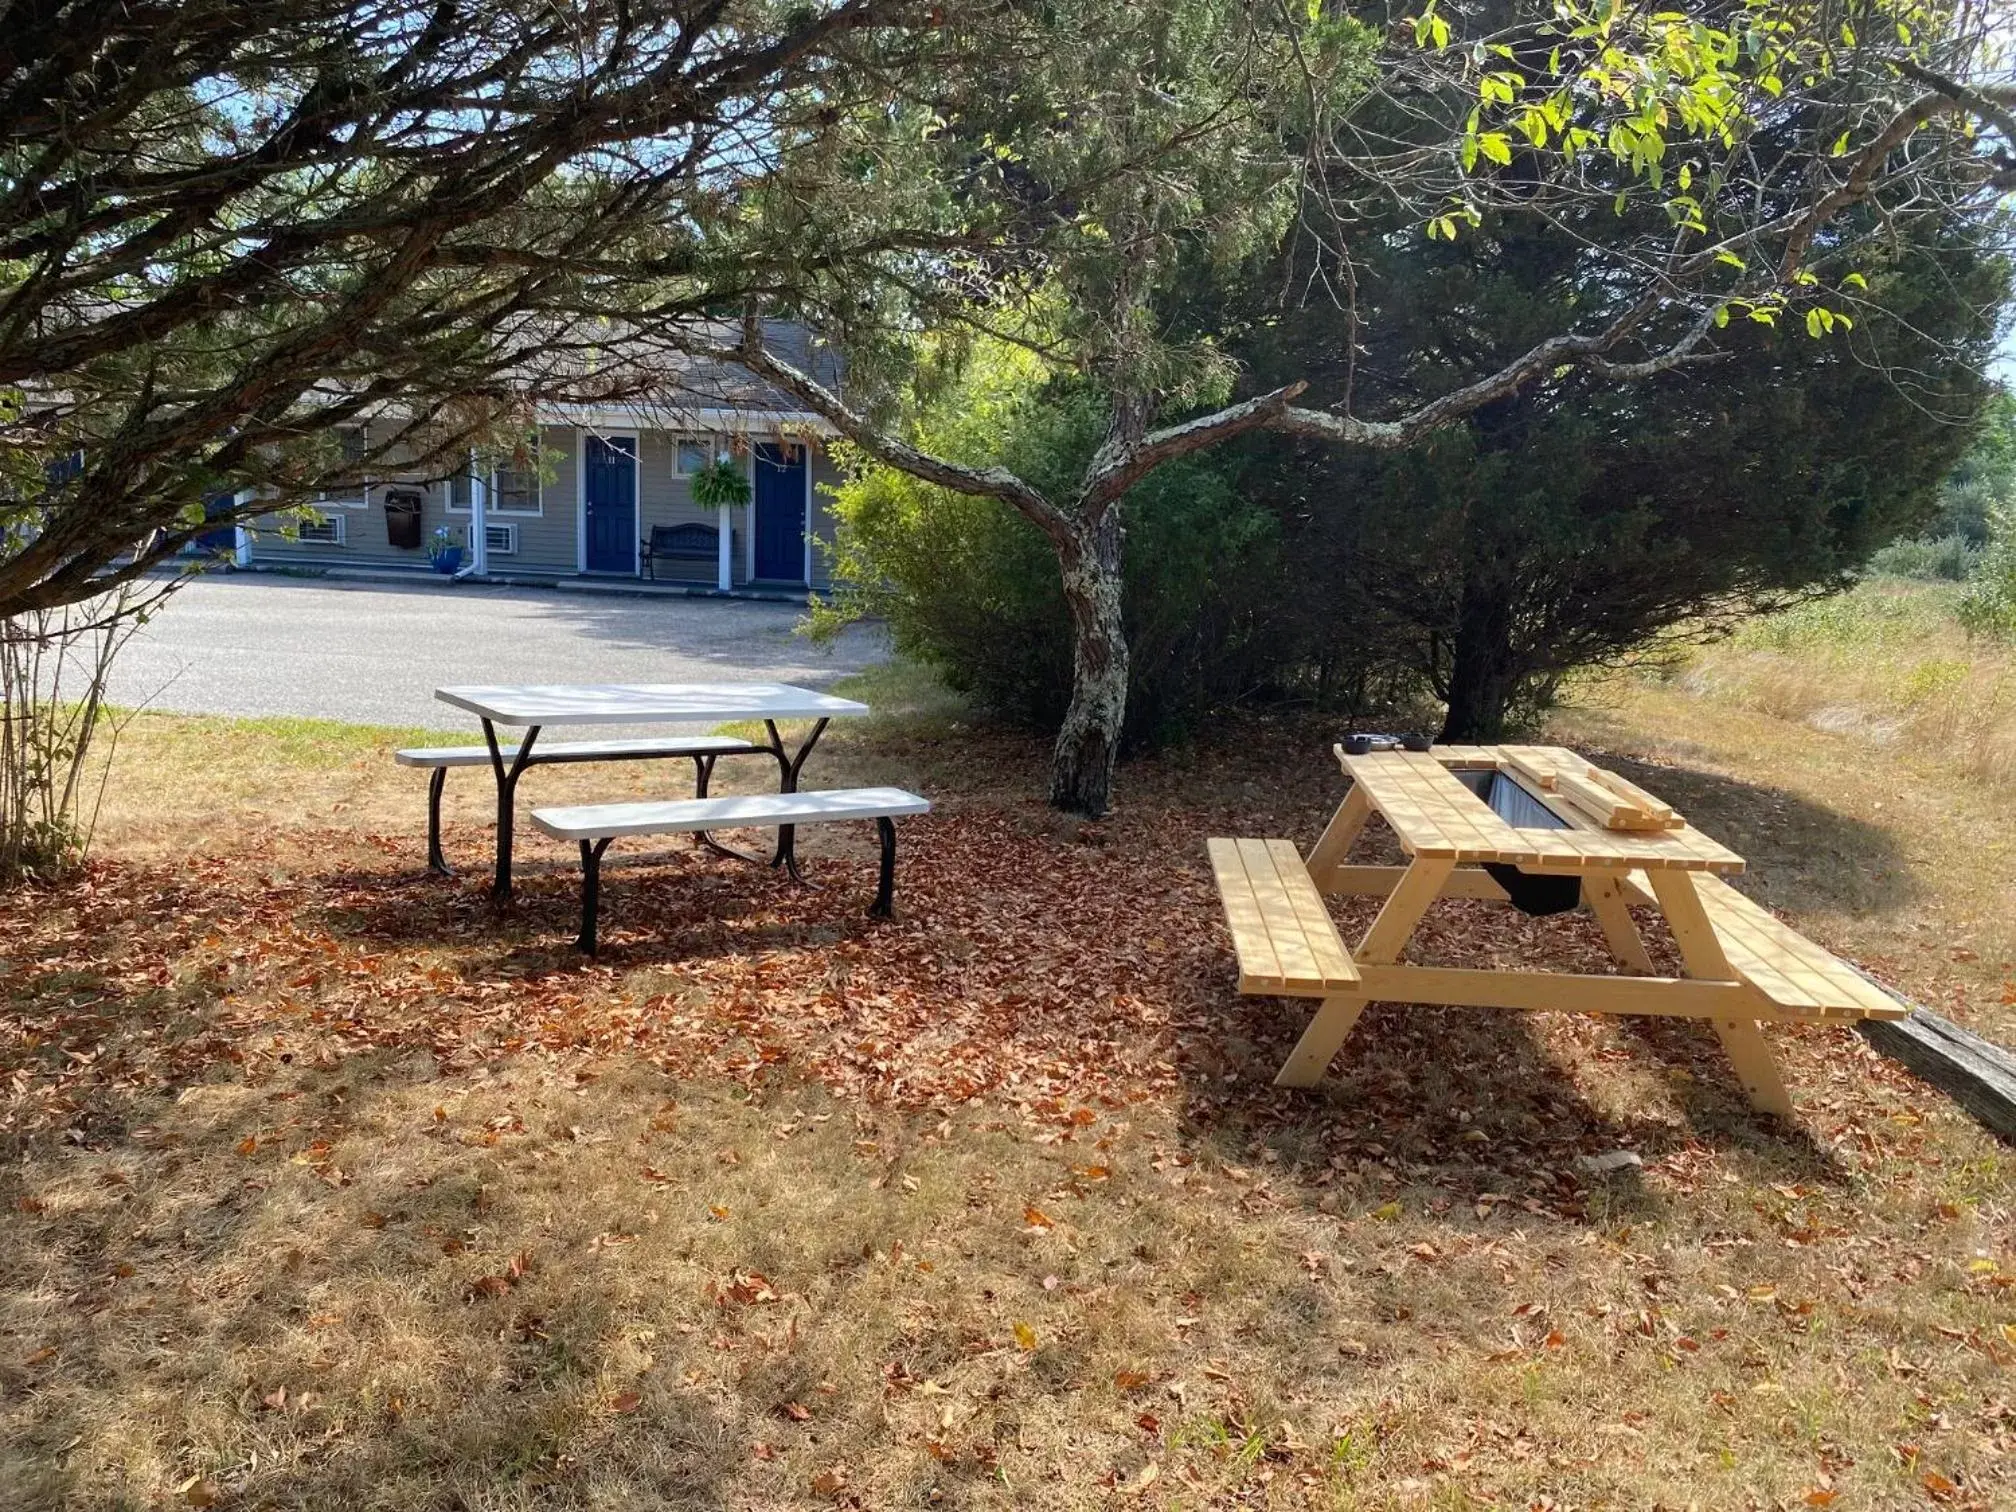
[532,788,931,956]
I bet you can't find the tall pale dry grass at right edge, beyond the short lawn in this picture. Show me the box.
[1667,579,2016,790]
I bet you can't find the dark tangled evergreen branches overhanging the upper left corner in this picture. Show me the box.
[0,0,929,615]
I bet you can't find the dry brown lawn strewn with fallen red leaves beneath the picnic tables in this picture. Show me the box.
[0,685,2016,1508]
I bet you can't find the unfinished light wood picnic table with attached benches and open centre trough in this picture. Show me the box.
[1208,746,1907,1117]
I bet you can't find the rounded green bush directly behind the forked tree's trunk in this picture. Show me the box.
[814,349,1282,746]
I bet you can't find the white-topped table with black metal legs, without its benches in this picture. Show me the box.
[433,683,869,901]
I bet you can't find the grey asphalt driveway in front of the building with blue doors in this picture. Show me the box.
[113,575,885,734]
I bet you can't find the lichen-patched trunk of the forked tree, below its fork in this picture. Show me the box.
[1050,508,1127,818]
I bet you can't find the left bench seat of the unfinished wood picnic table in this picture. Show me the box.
[1206,839,1359,998]
